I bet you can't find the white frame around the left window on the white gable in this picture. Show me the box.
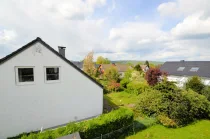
[15,66,36,85]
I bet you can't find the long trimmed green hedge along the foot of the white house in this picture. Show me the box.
[9,108,134,139]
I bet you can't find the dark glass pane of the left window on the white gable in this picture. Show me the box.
[18,68,34,82]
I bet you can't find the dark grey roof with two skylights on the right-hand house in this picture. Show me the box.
[160,61,210,78]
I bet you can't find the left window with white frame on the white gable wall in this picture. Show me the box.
[15,67,35,85]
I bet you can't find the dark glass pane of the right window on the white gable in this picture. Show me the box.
[46,68,59,80]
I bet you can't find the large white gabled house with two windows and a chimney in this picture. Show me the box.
[0,38,103,139]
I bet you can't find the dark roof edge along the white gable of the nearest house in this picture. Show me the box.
[0,37,103,88]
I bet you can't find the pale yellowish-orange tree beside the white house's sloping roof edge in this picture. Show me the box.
[83,51,96,76]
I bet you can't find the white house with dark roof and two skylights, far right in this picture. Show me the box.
[160,60,210,87]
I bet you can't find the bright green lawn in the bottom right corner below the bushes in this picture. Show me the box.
[126,120,210,139]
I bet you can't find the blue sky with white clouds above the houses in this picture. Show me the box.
[0,0,210,61]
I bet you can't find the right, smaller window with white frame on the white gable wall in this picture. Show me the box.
[45,67,60,83]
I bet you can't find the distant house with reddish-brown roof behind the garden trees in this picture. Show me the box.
[98,63,130,77]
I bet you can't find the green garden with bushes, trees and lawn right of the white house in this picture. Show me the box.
[100,61,210,139]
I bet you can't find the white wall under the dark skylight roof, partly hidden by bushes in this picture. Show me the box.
[167,75,210,87]
